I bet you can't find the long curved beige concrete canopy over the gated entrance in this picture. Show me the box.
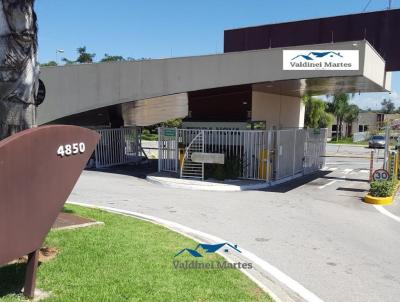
[38,41,390,124]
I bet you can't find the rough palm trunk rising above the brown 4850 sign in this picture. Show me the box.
[0,0,39,140]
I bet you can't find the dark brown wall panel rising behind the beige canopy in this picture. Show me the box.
[224,9,400,71]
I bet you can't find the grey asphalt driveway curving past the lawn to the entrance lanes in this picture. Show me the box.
[69,145,400,302]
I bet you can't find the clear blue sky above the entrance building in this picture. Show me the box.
[35,0,400,109]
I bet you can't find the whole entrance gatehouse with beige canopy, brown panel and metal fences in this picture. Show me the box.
[38,10,400,183]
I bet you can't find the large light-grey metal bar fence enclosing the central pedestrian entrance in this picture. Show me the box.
[159,128,327,182]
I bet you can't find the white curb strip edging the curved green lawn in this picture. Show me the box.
[67,201,323,302]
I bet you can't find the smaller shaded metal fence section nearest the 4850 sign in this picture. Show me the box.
[95,127,145,168]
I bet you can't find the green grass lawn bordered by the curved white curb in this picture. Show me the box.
[0,205,272,302]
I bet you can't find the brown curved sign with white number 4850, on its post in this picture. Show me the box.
[0,126,100,297]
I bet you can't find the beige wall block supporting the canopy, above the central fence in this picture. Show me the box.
[251,91,304,129]
